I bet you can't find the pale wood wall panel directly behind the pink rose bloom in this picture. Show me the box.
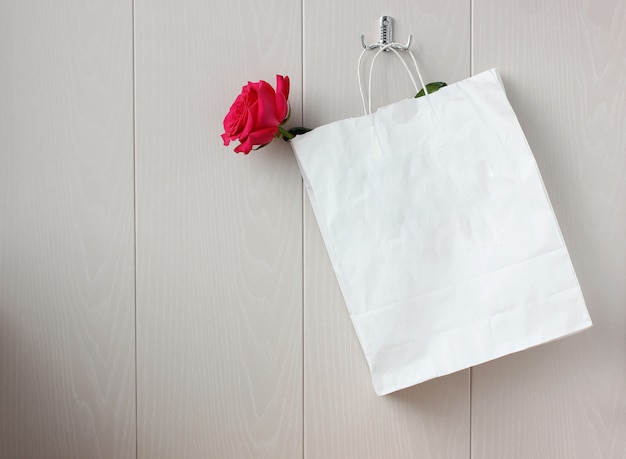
[135,0,302,459]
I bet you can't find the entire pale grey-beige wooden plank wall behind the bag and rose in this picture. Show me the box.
[0,0,626,459]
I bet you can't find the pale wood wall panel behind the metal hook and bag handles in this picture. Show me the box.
[304,0,470,459]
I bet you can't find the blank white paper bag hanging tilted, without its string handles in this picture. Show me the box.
[291,70,591,395]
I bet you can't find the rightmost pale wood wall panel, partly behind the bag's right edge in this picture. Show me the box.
[472,0,626,459]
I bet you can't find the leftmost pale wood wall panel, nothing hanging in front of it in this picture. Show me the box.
[0,0,135,459]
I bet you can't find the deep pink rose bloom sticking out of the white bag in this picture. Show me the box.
[222,75,289,154]
